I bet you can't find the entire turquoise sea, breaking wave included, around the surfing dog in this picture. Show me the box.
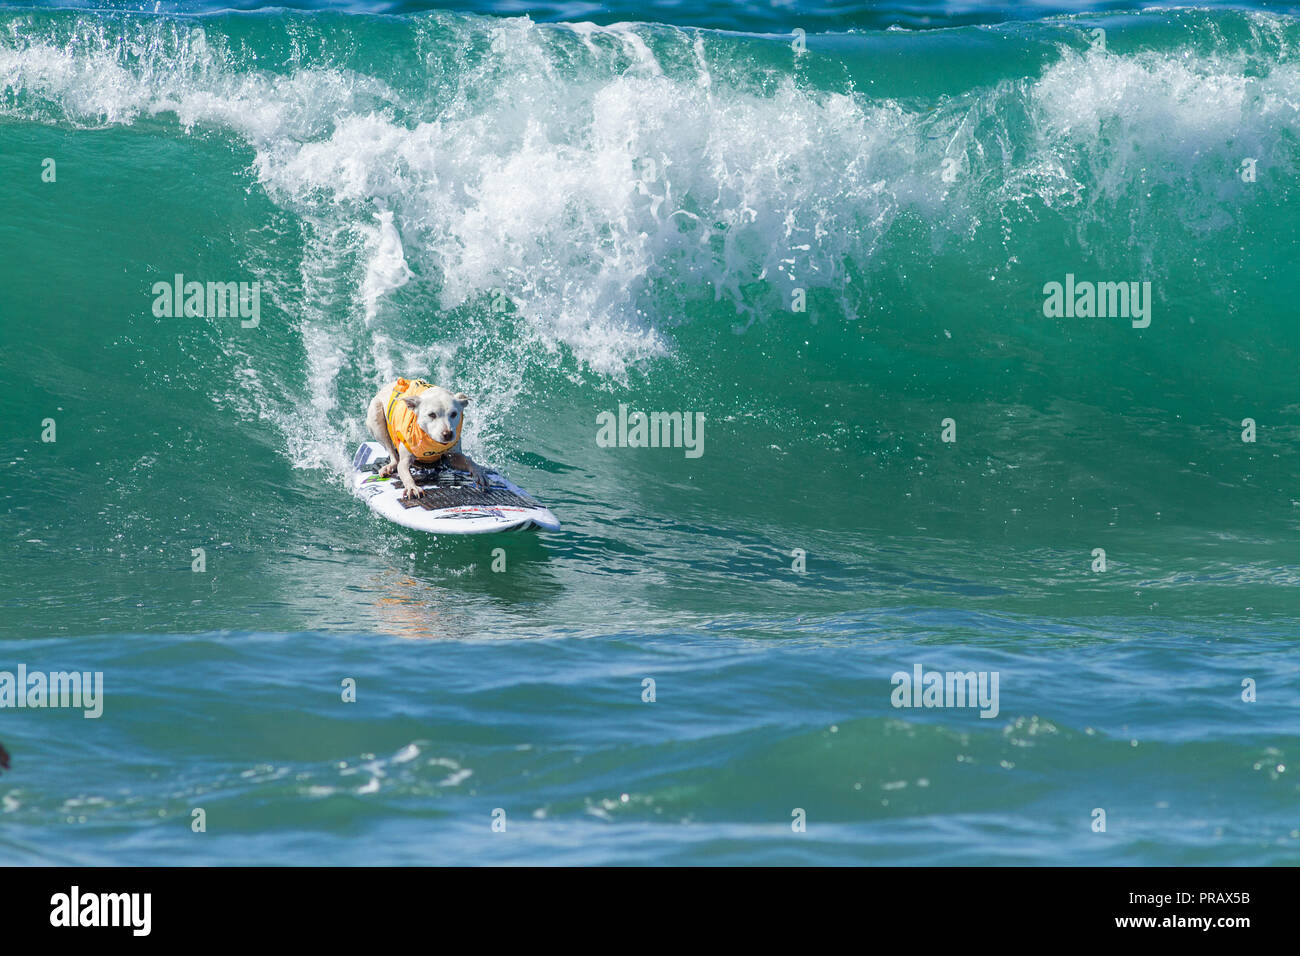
[0,4,1300,864]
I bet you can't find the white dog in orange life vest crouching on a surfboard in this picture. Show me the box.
[365,378,490,498]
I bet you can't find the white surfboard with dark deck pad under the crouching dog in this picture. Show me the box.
[351,441,560,535]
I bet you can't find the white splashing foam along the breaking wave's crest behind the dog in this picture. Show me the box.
[0,9,1300,466]
